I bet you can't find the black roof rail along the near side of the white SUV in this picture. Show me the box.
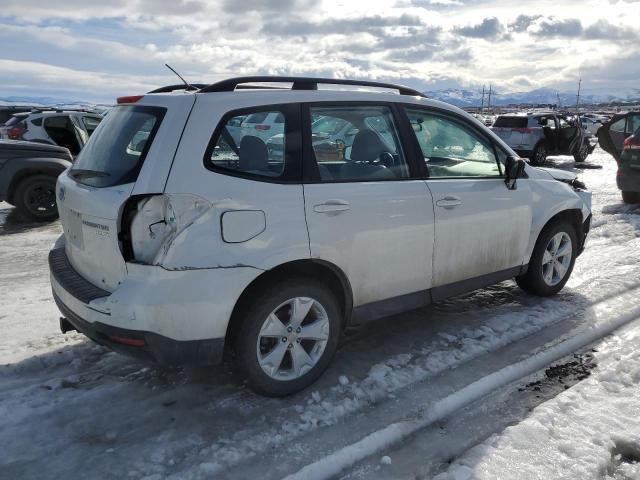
[195,75,425,97]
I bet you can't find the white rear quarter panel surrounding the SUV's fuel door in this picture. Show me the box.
[162,94,311,270]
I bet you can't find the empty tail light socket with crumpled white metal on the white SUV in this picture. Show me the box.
[121,194,211,265]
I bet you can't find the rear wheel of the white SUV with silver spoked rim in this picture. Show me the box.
[235,278,342,397]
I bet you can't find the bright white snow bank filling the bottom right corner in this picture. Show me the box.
[434,321,640,480]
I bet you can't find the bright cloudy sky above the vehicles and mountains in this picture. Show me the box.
[0,0,640,102]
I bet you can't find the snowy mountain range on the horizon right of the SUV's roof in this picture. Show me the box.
[424,88,640,107]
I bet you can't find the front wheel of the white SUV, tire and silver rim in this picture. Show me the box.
[516,221,578,297]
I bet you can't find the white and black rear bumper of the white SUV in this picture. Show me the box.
[49,237,259,365]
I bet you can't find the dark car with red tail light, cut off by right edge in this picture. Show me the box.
[598,112,640,203]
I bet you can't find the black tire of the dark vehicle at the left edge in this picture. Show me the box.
[13,175,58,222]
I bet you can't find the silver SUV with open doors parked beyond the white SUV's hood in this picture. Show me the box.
[491,112,598,165]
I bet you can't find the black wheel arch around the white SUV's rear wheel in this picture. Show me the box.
[225,259,353,347]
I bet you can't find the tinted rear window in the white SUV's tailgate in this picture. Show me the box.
[69,105,166,187]
